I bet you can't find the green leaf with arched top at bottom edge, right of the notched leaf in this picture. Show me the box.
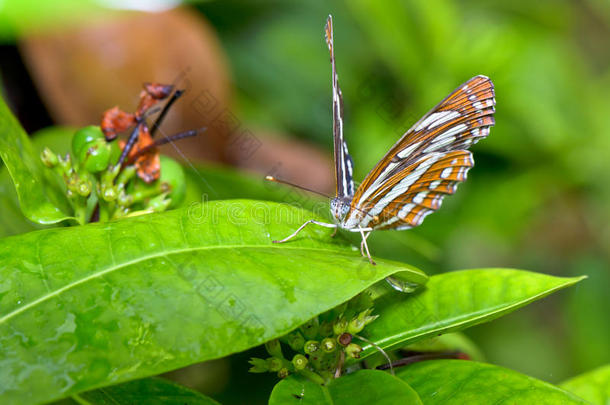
[396,360,586,405]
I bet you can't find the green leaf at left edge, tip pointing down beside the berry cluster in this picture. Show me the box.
[0,98,72,224]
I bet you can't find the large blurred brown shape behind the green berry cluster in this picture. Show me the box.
[19,8,230,161]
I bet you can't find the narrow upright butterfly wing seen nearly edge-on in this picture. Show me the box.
[324,15,354,197]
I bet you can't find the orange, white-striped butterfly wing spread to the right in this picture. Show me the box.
[343,76,495,229]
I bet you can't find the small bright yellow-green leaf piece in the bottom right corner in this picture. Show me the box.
[559,364,610,405]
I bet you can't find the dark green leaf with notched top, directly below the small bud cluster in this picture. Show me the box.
[269,370,422,405]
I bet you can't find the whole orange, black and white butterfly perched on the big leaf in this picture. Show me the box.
[268,15,496,265]
